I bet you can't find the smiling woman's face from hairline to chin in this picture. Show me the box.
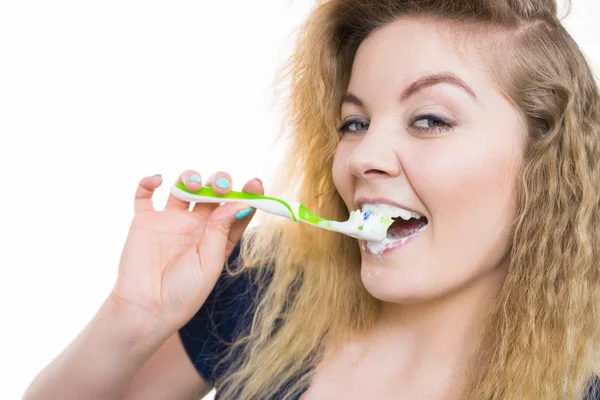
[333,19,525,302]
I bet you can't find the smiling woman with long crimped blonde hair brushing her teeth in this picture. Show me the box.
[26,0,600,400]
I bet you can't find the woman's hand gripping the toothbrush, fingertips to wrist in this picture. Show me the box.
[109,171,264,332]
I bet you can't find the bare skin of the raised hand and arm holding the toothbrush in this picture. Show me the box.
[23,171,264,400]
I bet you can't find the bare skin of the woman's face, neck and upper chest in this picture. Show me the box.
[302,19,525,400]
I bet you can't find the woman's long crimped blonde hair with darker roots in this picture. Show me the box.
[216,0,600,400]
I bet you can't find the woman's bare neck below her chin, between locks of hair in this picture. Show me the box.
[363,263,507,392]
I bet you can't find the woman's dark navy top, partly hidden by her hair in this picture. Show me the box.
[179,243,600,400]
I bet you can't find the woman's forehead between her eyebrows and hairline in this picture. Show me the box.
[349,18,492,96]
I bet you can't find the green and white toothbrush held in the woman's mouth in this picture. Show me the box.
[170,183,394,241]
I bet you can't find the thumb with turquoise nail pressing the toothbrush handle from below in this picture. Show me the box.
[197,202,251,279]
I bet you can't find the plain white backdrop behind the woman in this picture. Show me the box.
[0,0,600,399]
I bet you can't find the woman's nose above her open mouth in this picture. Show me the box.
[346,124,402,179]
